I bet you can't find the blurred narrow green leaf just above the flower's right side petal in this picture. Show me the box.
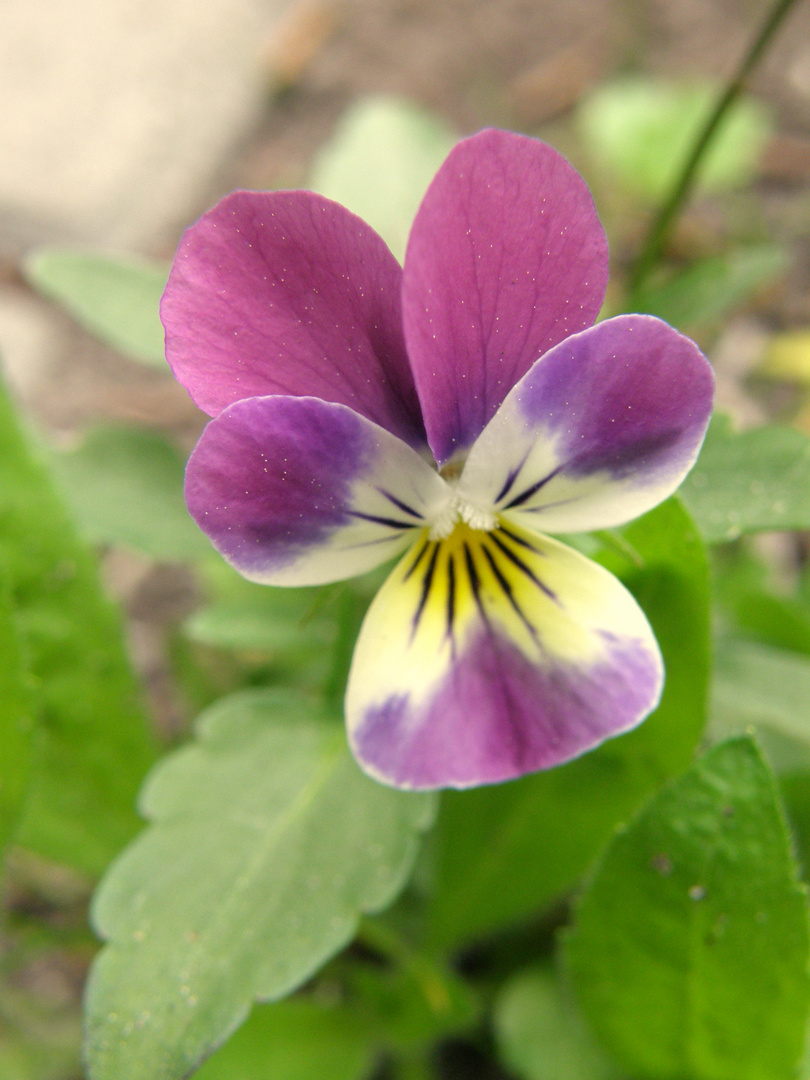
[627,244,787,328]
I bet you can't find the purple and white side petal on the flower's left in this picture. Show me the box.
[186,395,447,585]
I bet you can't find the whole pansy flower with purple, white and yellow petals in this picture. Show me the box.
[162,130,713,788]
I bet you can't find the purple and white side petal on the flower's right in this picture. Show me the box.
[459,315,714,532]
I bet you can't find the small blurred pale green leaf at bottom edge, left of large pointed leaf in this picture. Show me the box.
[494,968,621,1080]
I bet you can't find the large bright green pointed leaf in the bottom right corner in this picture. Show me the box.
[567,738,809,1080]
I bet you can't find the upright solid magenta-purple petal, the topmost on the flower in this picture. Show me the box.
[403,131,608,462]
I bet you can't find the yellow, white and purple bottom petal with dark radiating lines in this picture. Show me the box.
[346,525,663,788]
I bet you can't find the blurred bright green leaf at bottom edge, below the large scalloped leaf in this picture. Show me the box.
[194,998,375,1080]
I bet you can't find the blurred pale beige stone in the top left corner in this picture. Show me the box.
[0,0,291,256]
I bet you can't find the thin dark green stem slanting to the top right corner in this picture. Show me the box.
[629,0,797,296]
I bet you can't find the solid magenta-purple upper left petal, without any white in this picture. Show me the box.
[161,191,424,445]
